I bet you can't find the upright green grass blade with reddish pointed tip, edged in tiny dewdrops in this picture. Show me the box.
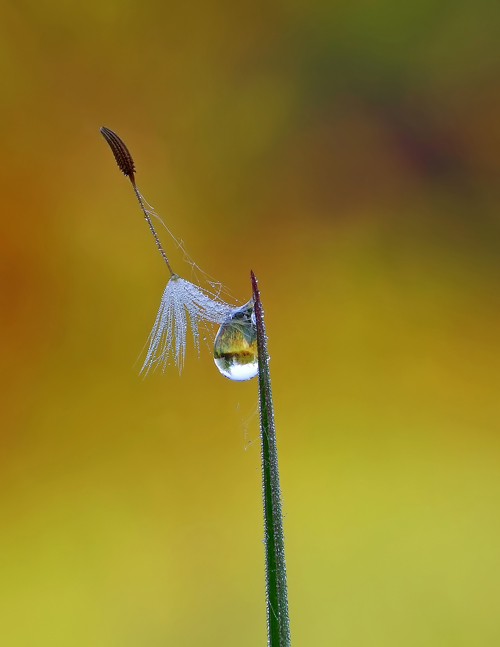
[251,272,290,647]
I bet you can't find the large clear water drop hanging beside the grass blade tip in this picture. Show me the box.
[214,301,259,381]
